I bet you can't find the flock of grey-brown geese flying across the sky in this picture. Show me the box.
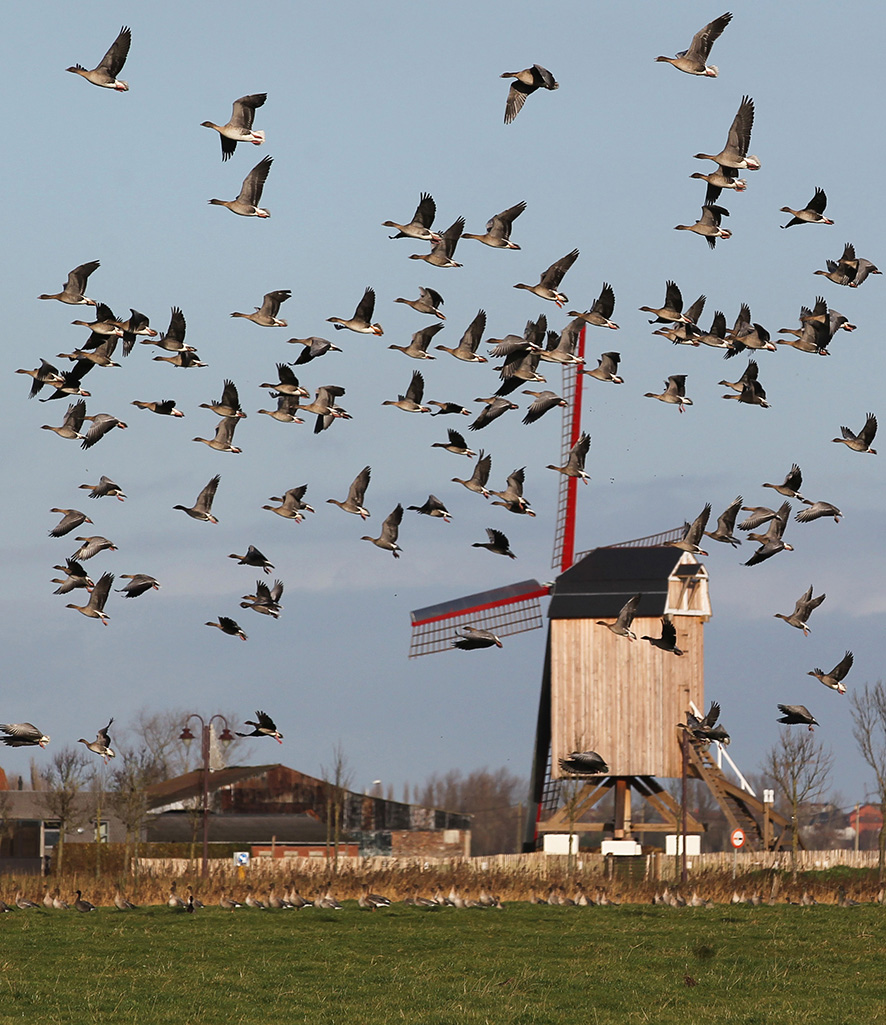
[0,12,881,815]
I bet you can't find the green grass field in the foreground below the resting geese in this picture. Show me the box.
[0,905,886,1025]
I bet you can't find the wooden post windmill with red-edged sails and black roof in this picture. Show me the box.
[409,329,788,850]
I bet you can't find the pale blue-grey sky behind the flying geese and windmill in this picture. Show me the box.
[0,0,886,815]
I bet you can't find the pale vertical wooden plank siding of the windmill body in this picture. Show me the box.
[551,615,710,778]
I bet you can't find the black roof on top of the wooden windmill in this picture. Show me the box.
[548,546,700,619]
